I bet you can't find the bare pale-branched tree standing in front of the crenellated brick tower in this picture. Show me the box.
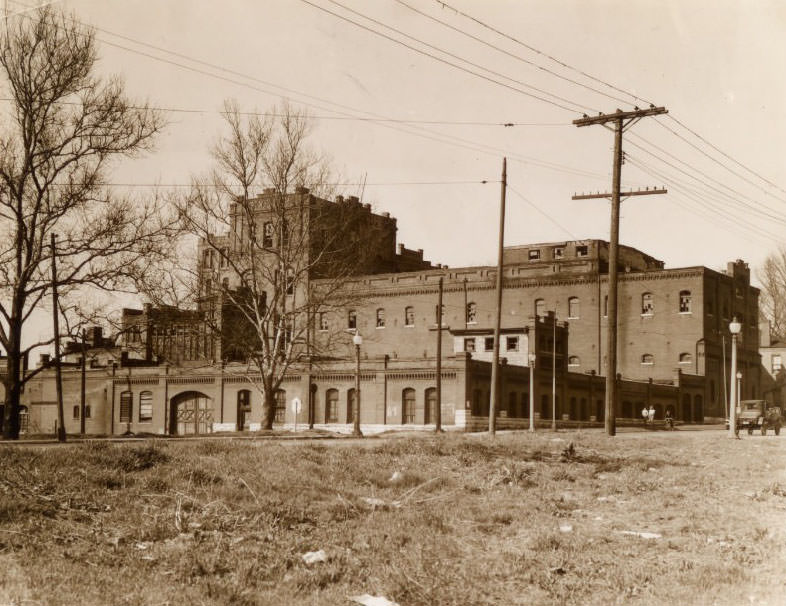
[179,103,376,429]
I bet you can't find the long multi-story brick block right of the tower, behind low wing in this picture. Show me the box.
[317,240,761,420]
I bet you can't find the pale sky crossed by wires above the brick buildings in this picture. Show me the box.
[16,0,786,276]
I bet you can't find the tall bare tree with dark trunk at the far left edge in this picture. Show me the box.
[0,8,169,439]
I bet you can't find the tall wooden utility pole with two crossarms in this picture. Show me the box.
[573,105,667,436]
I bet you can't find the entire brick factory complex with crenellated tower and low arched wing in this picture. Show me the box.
[21,190,762,433]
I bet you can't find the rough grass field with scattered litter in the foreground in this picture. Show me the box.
[0,431,786,606]
